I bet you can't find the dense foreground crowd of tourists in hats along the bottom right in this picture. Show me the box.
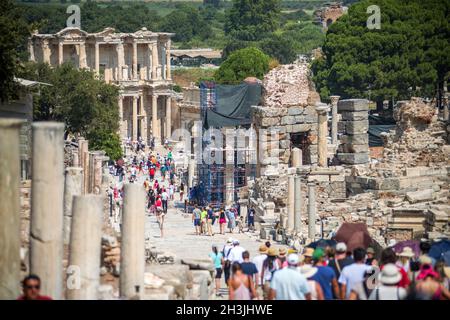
[209,238,450,300]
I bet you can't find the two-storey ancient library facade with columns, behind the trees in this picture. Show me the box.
[28,28,174,143]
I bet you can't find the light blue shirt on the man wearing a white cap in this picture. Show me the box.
[270,267,310,300]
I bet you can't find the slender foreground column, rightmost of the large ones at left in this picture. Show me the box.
[119,184,145,298]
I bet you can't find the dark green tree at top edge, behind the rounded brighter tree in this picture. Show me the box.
[224,0,281,41]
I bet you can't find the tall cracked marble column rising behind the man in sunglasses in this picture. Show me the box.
[30,122,64,300]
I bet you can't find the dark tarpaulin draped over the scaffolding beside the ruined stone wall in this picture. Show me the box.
[203,83,261,128]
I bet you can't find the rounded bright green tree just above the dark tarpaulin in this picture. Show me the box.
[214,47,270,84]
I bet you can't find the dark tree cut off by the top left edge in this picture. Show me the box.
[0,0,29,101]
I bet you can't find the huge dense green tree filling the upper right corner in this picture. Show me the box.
[313,0,450,102]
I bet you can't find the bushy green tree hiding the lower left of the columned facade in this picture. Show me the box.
[21,62,122,159]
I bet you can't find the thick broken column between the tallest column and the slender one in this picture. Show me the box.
[66,194,104,300]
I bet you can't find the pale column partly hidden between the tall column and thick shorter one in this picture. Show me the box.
[63,167,83,244]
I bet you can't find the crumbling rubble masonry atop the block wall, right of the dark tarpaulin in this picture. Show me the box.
[263,63,312,107]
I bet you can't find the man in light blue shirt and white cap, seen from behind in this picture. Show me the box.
[269,253,311,300]
